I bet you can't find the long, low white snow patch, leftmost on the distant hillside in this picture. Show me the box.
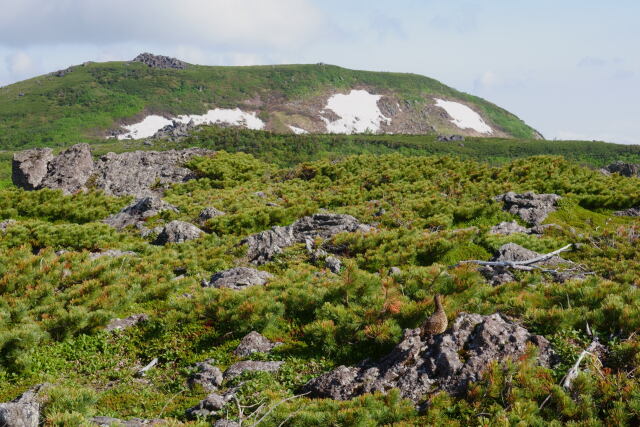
[118,108,264,139]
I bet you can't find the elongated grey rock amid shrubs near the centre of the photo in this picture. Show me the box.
[243,213,371,264]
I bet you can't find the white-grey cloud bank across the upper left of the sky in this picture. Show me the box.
[0,0,325,48]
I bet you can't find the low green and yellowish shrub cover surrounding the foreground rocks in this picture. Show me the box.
[0,152,640,426]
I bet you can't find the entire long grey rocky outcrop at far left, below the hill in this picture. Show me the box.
[12,144,214,198]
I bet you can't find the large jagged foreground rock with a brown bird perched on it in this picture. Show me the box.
[305,313,554,403]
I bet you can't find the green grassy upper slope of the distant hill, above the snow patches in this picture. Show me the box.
[0,62,536,149]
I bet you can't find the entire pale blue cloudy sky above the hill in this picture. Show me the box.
[0,0,640,144]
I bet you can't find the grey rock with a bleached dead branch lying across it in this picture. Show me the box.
[479,243,568,286]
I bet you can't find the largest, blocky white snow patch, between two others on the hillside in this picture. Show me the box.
[320,90,391,133]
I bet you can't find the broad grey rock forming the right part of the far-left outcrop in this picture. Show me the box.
[93,148,215,198]
